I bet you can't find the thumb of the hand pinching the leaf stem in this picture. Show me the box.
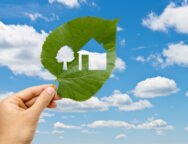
[31,87,56,115]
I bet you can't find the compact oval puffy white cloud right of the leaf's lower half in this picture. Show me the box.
[133,76,179,98]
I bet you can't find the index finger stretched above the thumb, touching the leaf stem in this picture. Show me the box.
[16,84,56,101]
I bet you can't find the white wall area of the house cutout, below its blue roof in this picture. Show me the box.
[78,40,107,70]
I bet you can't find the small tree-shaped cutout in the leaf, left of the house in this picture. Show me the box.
[56,45,74,70]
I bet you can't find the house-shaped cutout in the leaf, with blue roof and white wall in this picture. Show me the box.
[78,39,107,71]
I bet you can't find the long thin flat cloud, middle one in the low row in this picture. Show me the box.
[87,120,135,129]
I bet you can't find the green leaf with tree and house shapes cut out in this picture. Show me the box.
[41,17,119,101]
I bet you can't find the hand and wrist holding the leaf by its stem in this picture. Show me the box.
[0,85,60,144]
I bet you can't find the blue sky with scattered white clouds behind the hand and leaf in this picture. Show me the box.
[0,0,188,144]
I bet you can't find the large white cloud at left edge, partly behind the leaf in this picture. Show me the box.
[0,22,55,80]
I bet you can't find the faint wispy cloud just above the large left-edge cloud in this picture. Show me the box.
[24,12,59,22]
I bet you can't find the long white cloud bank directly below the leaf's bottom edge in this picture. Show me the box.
[53,90,152,112]
